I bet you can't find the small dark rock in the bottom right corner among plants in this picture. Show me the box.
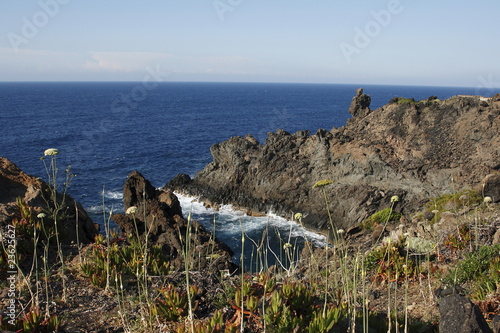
[439,294,493,333]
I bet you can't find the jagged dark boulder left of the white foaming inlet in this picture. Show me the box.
[112,171,237,274]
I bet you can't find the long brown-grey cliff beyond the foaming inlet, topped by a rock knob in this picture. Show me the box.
[166,89,500,229]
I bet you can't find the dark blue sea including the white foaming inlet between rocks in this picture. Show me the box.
[0,82,488,268]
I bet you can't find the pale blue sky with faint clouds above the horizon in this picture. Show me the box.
[0,0,500,87]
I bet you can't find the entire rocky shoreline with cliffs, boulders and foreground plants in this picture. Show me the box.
[0,90,500,333]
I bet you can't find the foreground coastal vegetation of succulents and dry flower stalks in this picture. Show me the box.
[0,154,500,332]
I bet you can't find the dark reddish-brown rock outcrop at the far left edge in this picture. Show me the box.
[0,157,98,243]
